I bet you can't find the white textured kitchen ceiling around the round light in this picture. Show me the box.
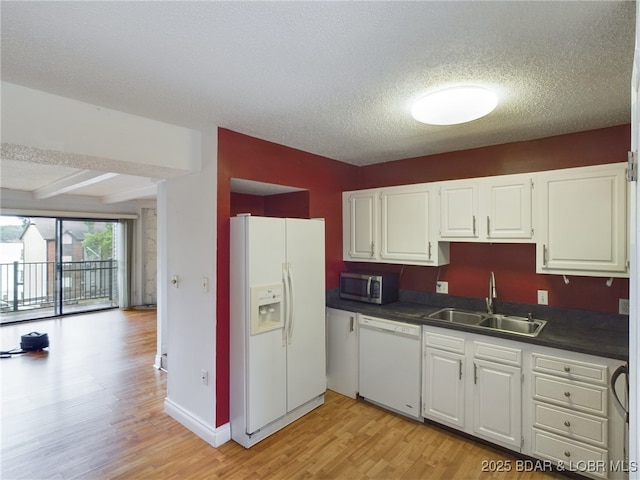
[0,1,635,201]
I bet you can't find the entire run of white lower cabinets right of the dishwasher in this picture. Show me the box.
[422,326,628,479]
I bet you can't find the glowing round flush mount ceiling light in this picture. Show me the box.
[411,86,498,125]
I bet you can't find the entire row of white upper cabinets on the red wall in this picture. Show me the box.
[343,163,629,277]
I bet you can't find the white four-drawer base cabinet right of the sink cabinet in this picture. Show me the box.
[524,348,626,478]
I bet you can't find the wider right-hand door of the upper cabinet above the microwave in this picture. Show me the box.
[380,185,437,263]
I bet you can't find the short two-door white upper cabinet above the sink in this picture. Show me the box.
[439,175,533,243]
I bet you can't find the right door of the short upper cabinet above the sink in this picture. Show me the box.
[486,175,533,240]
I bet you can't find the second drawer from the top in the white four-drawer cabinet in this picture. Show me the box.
[533,374,608,417]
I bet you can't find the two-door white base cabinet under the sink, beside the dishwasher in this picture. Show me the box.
[422,326,522,451]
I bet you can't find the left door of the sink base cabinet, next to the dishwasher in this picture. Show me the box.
[422,347,465,429]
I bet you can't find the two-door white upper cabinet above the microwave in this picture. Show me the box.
[343,184,449,265]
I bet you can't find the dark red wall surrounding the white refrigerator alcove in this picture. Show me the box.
[216,128,358,426]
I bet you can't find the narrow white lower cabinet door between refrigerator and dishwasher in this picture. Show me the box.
[327,308,358,398]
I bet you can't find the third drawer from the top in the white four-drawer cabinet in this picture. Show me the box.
[533,402,608,448]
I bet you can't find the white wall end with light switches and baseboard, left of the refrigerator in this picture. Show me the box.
[158,129,230,446]
